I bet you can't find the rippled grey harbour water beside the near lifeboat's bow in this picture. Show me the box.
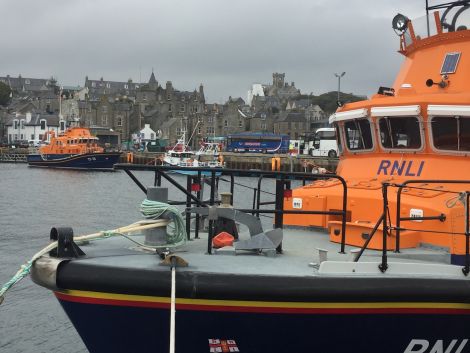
[0,164,282,353]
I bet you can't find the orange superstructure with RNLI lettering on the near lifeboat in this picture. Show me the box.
[284,3,470,255]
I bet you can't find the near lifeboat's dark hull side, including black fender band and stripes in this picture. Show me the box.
[46,261,470,353]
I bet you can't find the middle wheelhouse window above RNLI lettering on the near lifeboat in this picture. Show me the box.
[379,116,422,149]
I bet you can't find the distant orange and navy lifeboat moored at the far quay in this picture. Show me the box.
[27,127,121,170]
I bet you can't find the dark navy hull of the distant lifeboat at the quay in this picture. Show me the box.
[27,152,121,170]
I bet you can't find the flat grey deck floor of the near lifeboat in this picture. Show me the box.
[74,228,453,277]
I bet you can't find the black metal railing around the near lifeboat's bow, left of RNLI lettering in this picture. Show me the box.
[114,164,347,254]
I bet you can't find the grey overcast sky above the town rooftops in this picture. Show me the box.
[0,0,425,103]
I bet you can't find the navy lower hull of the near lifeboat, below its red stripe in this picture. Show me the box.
[59,294,470,353]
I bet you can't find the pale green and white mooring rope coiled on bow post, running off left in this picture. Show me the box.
[0,199,186,304]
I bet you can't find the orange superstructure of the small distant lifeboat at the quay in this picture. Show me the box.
[39,127,104,155]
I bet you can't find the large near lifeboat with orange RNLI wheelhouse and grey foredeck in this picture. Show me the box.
[4,1,470,353]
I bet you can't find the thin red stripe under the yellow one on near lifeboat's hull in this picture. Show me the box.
[55,292,470,315]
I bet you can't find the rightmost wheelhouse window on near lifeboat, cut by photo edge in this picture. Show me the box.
[431,116,470,151]
